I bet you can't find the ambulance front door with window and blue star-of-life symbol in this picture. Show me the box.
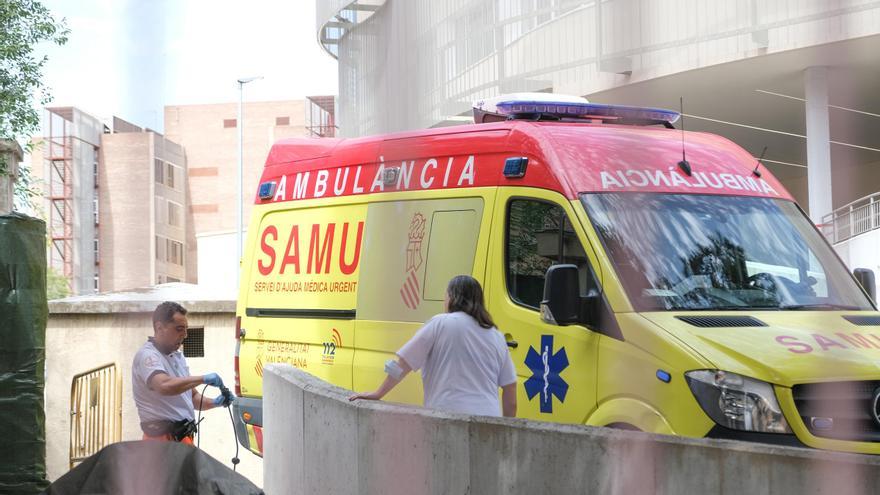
[486,188,600,423]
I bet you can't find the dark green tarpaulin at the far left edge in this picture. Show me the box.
[0,213,49,494]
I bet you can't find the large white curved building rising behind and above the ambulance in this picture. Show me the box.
[316,0,880,276]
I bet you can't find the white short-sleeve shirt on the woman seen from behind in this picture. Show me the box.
[397,312,516,416]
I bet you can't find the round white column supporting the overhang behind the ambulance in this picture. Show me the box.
[804,67,832,224]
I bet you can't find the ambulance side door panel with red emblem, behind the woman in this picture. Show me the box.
[353,189,494,405]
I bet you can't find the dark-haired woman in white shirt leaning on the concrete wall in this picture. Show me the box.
[350,275,516,417]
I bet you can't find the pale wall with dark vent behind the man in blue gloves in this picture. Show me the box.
[46,308,263,485]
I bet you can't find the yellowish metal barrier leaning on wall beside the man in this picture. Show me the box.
[70,363,122,469]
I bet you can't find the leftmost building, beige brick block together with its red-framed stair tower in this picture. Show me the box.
[31,107,196,295]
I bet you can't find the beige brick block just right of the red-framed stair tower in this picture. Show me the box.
[98,118,195,292]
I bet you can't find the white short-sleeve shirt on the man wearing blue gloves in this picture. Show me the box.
[131,338,195,423]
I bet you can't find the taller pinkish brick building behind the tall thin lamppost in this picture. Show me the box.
[165,100,312,288]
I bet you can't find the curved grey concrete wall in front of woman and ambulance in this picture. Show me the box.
[263,364,880,495]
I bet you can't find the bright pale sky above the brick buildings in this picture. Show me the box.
[41,0,338,132]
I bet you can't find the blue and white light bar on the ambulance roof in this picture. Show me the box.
[473,93,680,127]
